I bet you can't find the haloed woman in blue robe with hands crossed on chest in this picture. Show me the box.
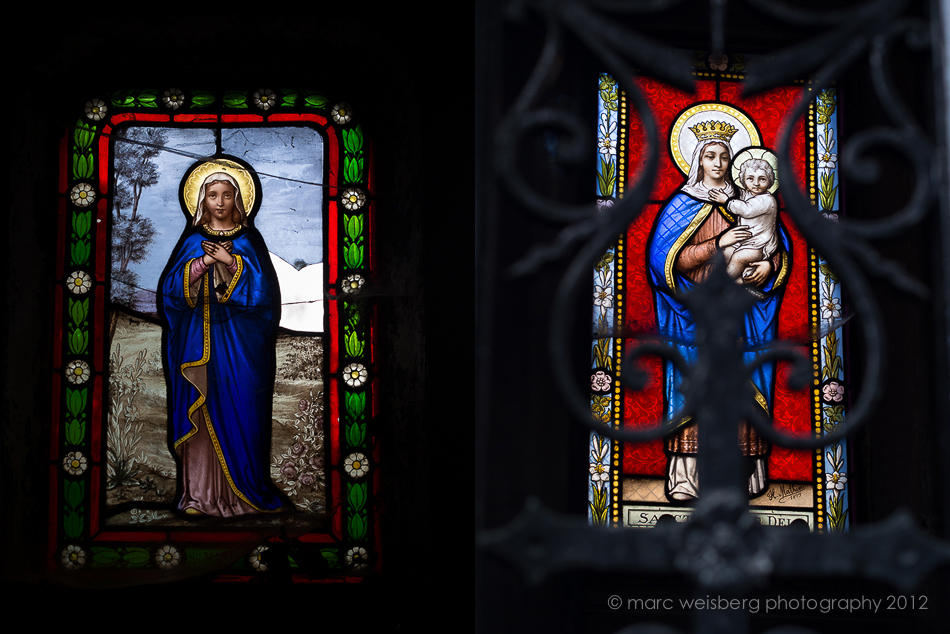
[158,159,285,517]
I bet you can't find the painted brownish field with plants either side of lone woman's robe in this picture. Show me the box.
[106,314,326,524]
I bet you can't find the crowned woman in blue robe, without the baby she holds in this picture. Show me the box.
[647,104,791,501]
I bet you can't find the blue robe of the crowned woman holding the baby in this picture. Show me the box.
[647,192,791,432]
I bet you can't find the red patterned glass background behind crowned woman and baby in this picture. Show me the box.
[621,78,813,481]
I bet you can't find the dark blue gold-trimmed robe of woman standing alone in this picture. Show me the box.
[159,228,284,511]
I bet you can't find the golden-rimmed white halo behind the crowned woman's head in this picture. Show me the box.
[670,101,761,175]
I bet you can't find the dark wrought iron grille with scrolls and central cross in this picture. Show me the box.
[488,0,950,633]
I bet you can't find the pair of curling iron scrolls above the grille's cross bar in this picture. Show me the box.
[497,0,940,448]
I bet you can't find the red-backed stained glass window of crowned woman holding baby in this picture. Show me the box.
[588,58,849,531]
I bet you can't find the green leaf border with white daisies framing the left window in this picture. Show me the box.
[50,88,380,574]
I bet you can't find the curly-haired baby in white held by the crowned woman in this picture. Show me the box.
[709,158,779,280]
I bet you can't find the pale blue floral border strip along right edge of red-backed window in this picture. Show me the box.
[810,88,850,532]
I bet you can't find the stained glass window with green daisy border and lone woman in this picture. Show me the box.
[49,88,381,581]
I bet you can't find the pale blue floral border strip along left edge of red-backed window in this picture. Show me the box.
[588,75,620,526]
